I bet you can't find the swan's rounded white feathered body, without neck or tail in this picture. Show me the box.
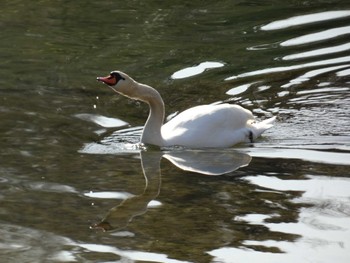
[162,104,254,147]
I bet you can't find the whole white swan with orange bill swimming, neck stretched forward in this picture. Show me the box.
[97,71,275,148]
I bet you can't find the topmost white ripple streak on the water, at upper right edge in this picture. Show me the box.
[261,10,350,31]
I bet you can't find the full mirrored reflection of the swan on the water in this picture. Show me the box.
[92,150,251,231]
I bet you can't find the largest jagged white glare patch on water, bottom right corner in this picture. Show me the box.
[208,176,350,263]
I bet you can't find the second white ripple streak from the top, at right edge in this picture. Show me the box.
[280,26,350,47]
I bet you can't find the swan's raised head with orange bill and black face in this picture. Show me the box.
[97,70,135,98]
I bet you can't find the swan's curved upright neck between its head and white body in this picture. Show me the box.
[137,83,164,146]
